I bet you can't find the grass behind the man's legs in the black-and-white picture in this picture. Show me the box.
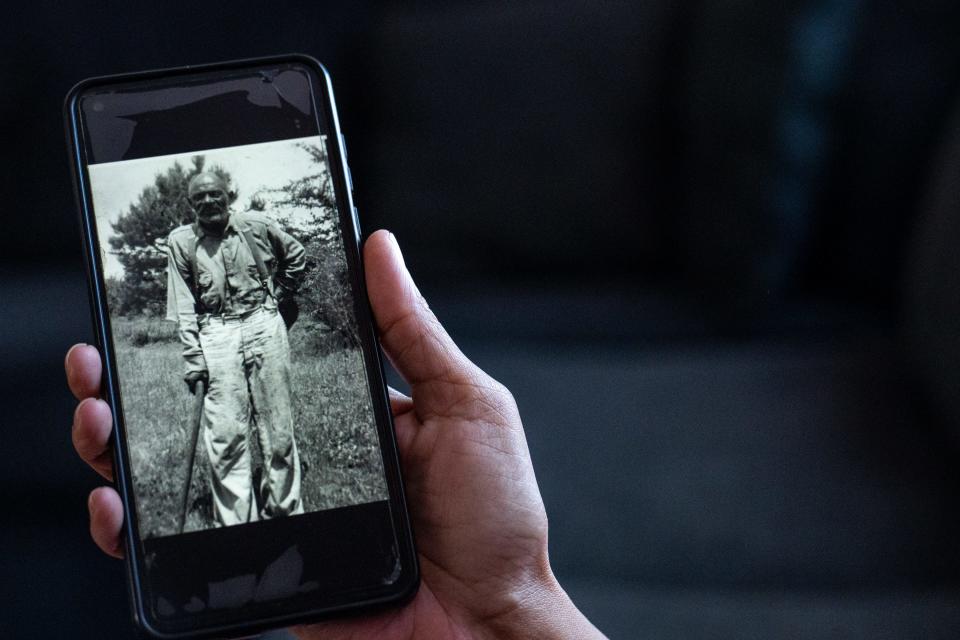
[113,318,387,537]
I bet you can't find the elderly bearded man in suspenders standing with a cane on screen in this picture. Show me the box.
[167,173,305,526]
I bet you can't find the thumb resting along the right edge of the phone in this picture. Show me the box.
[363,230,475,388]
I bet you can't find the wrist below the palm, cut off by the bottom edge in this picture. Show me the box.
[484,571,606,640]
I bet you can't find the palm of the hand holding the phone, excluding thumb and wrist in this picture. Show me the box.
[301,379,547,639]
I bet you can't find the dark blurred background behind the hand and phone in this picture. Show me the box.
[0,0,960,638]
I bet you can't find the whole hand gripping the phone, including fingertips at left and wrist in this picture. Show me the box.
[67,231,603,639]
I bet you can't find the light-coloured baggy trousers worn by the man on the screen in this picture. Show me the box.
[199,307,303,526]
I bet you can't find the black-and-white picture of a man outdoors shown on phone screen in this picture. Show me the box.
[89,136,387,538]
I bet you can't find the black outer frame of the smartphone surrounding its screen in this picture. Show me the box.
[64,54,419,638]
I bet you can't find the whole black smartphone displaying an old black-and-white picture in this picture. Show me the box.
[65,55,419,638]
